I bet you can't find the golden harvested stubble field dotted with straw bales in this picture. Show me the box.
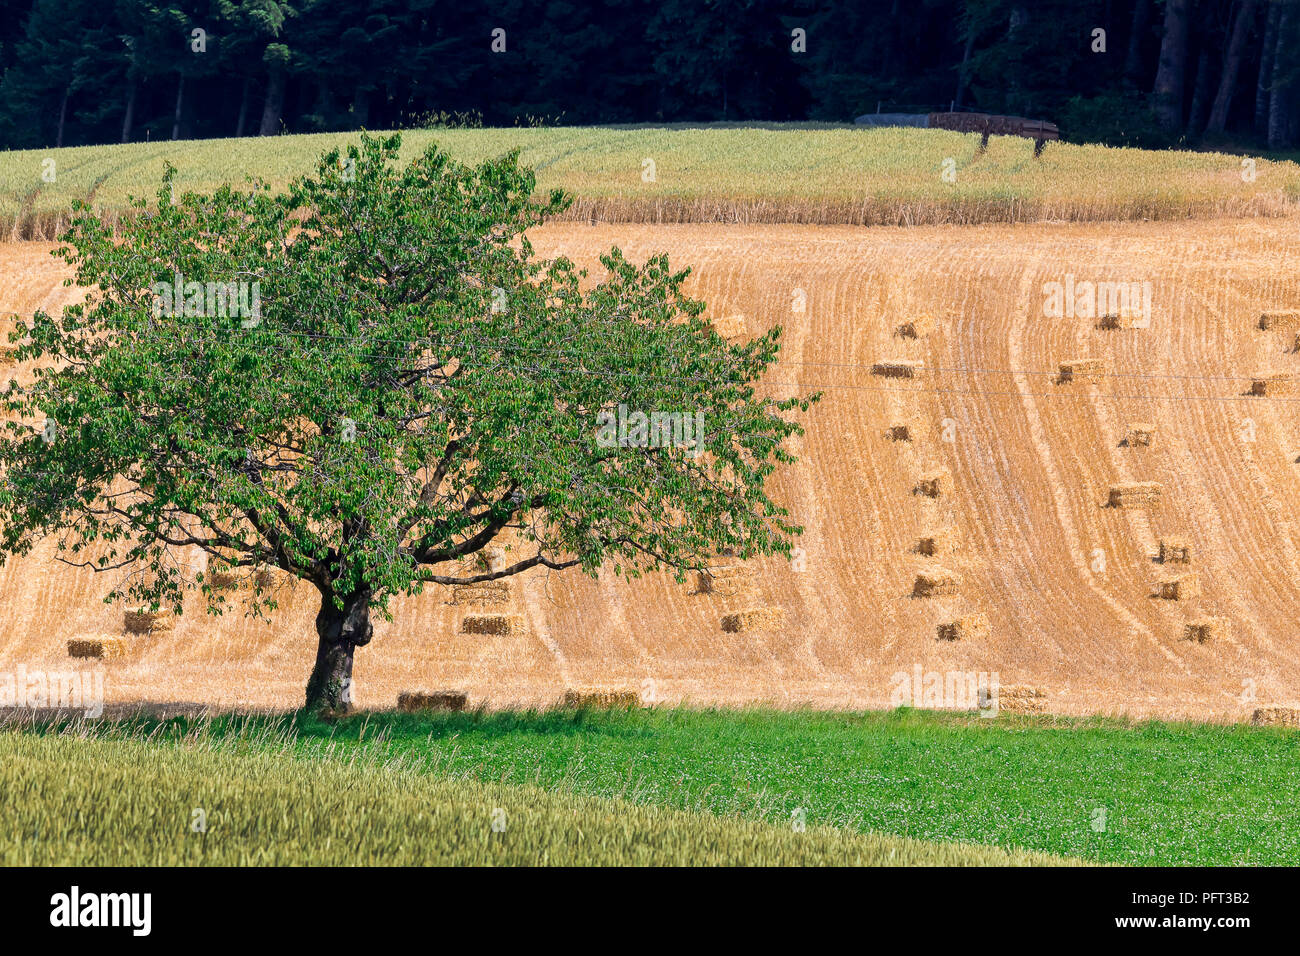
[0,219,1300,721]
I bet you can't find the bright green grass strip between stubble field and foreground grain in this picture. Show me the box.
[4,709,1300,865]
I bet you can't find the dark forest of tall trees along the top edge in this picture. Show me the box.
[0,0,1300,148]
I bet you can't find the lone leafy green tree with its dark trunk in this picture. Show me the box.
[0,137,815,711]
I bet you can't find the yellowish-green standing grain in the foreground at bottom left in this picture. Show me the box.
[0,734,1061,866]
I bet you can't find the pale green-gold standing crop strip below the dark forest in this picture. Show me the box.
[0,124,1300,238]
